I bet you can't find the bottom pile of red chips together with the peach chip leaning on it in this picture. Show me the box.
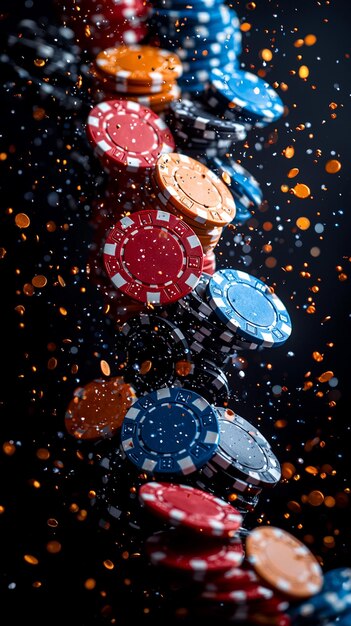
[139,482,326,626]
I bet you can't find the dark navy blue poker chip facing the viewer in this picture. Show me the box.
[121,387,219,475]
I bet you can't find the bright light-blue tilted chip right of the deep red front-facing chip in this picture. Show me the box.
[207,269,292,348]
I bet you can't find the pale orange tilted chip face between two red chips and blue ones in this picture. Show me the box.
[154,152,236,226]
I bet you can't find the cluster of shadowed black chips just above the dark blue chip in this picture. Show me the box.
[120,312,230,404]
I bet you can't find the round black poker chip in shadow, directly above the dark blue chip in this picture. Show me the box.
[121,313,190,392]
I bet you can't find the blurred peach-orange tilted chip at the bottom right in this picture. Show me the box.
[246,526,323,600]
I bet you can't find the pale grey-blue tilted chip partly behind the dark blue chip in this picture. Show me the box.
[211,407,281,487]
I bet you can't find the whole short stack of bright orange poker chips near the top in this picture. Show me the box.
[90,45,182,113]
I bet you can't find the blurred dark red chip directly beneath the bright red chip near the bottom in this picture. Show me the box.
[146,530,244,575]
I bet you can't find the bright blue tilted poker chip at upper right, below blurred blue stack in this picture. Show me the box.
[210,67,284,127]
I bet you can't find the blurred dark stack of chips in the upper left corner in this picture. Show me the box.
[0,17,86,111]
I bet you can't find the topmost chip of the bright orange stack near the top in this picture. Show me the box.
[95,45,182,85]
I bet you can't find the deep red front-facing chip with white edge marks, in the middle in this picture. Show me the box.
[103,210,203,305]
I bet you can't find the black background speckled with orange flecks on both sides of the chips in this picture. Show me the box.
[0,0,351,626]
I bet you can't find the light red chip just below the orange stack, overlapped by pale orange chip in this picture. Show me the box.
[87,100,175,173]
